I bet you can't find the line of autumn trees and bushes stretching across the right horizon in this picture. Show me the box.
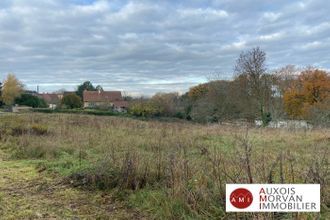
[130,47,330,126]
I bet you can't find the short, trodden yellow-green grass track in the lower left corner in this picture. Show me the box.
[0,150,140,219]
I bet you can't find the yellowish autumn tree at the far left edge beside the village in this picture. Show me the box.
[1,74,23,105]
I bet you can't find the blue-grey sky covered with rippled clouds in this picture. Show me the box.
[0,0,330,95]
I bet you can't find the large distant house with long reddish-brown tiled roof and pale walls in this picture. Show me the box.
[83,90,128,112]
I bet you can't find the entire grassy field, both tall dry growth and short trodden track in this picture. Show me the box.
[0,113,330,219]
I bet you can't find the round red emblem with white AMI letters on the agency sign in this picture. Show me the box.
[230,188,253,209]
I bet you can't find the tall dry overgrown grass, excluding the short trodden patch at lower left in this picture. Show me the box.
[0,113,330,219]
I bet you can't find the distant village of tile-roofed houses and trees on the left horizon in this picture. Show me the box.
[0,74,128,113]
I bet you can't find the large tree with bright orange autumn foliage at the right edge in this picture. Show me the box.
[283,69,330,119]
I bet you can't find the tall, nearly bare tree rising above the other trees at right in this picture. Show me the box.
[235,47,272,124]
